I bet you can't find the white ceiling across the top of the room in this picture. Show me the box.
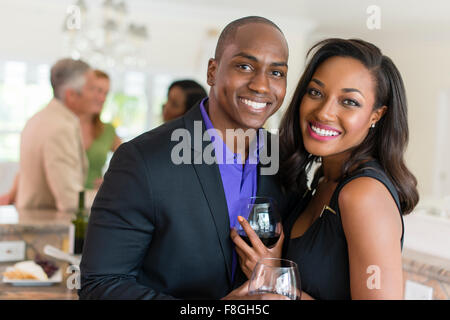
[4,0,450,31]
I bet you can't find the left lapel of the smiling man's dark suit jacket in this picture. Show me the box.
[184,105,233,285]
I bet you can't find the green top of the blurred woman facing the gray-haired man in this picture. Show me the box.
[85,123,116,189]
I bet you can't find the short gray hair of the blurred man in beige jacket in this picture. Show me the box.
[50,58,91,100]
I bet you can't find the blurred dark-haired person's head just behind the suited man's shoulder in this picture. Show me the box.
[163,80,207,122]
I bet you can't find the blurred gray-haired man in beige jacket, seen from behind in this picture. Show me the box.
[16,59,95,211]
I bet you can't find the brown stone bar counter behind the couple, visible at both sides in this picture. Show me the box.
[0,206,450,300]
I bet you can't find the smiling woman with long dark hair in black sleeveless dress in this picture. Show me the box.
[231,39,419,299]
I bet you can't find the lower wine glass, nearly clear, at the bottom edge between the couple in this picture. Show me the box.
[248,258,302,300]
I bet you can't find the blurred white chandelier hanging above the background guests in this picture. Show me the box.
[63,0,149,69]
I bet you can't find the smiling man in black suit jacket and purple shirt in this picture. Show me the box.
[79,17,288,299]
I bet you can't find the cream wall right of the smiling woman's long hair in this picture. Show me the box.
[390,41,450,197]
